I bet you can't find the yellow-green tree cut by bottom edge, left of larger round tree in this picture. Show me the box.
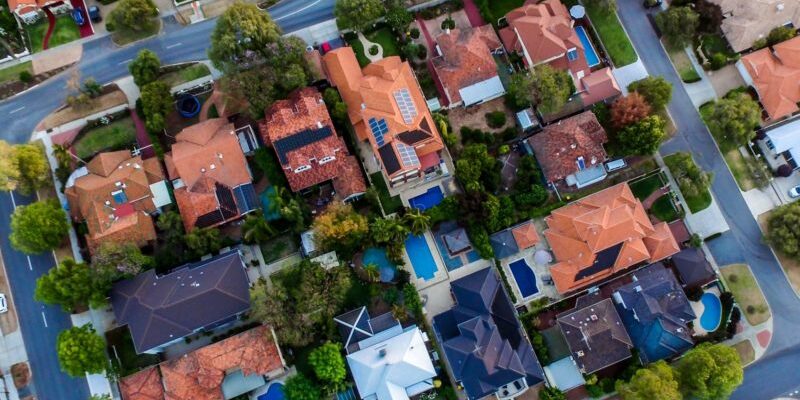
[617,360,682,400]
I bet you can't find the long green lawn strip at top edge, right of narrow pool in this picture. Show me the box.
[584,2,638,68]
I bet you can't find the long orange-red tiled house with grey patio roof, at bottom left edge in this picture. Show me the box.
[119,326,286,400]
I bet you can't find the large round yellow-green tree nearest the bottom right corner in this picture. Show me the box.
[675,343,744,400]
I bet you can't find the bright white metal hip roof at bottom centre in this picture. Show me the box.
[347,326,436,400]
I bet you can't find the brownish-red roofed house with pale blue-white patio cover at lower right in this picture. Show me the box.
[528,111,608,189]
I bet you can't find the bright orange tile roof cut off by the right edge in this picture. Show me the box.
[741,37,800,119]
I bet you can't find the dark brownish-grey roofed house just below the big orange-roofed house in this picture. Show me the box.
[556,293,633,375]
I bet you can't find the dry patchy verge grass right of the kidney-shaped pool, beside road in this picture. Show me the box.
[720,264,770,326]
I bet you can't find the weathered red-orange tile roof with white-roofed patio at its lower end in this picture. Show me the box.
[431,25,502,104]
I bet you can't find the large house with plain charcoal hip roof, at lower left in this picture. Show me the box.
[111,251,250,354]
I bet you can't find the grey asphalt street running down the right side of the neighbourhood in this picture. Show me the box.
[617,0,800,400]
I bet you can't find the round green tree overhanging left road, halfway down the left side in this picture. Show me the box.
[9,200,69,254]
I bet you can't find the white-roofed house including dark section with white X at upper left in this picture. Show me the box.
[334,307,437,400]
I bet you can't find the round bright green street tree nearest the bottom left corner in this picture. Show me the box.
[56,324,108,378]
